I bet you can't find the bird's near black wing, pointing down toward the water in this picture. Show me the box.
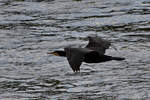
[65,48,84,72]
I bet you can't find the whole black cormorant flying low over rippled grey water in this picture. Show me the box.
[48,36,125,72]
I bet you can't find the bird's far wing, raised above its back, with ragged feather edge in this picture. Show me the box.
[85,36,111,54]
